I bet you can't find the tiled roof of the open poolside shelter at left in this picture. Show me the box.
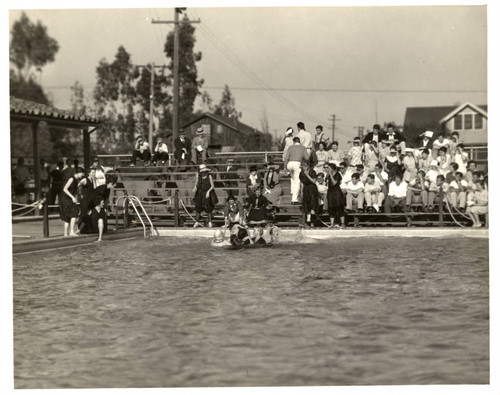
[10,96,100,127]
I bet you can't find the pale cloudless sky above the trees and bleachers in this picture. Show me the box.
[10,6,487,143]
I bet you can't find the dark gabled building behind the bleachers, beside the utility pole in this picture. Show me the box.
[181,113,264,152]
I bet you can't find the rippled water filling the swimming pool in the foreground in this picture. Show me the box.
[13,238,489,388]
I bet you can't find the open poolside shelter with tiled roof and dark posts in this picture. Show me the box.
[10,96,101,200]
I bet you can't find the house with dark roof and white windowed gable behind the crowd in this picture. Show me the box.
[404,102,488,146]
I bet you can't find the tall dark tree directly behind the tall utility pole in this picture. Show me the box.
[164,15,204,124]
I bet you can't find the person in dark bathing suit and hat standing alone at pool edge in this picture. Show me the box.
[193,164,219,228]
